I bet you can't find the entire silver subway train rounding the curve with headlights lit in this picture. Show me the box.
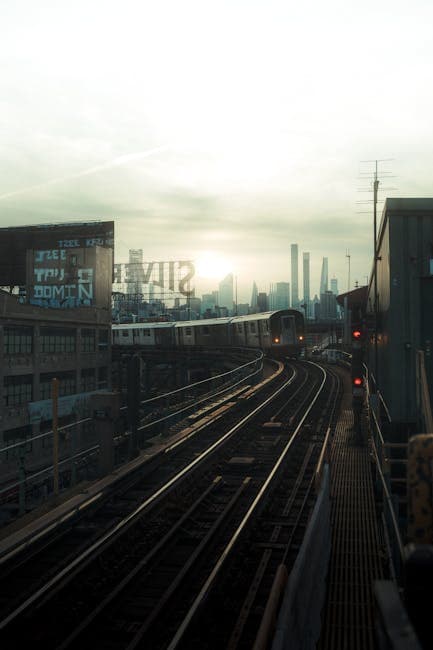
[113,309,305,358]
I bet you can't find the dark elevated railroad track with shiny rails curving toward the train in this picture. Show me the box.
[0,356,335,648]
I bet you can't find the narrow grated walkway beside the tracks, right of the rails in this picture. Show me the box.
[318,374,383,650]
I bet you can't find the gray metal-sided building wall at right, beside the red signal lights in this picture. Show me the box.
[367,199,433,422]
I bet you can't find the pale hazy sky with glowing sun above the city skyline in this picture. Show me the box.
[0,0,433,302]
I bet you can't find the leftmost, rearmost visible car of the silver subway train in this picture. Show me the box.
[112,323,175,347]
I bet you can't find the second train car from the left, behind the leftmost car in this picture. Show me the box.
[175,318,231,348]
